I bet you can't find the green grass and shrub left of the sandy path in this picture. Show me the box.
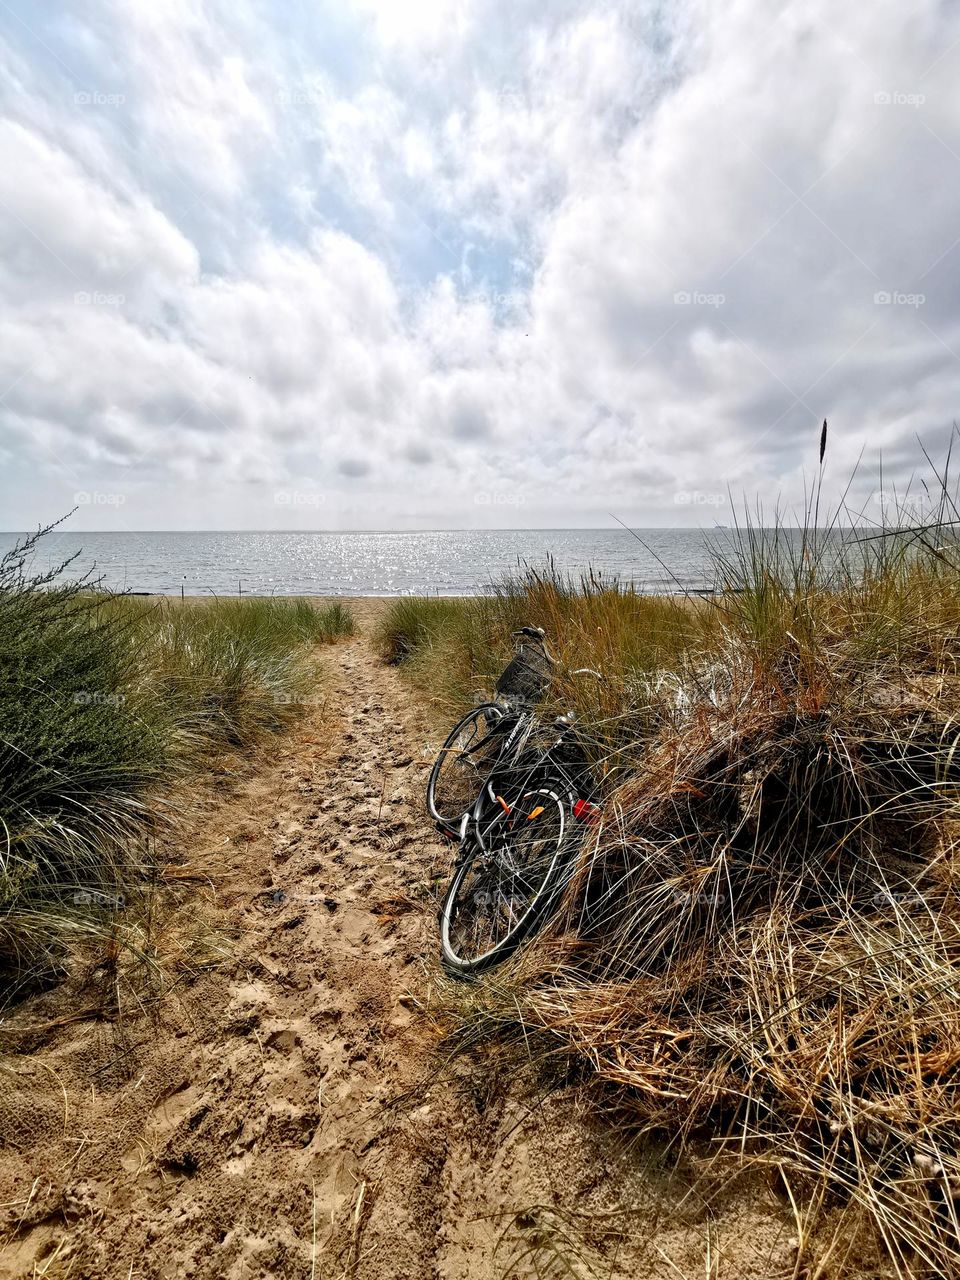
[0,535,352,989]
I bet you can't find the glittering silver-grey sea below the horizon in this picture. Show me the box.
[0,526,742,595]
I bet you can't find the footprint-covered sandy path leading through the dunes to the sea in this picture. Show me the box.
[0,605,781,1280]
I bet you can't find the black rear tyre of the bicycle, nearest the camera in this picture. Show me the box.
[440,780,570,978]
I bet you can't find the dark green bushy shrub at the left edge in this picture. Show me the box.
[0,535,170,957]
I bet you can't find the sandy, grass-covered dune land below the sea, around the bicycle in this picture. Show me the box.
[0,532,960,1280]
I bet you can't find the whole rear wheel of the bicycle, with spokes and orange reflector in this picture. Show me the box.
[440,782,568,977]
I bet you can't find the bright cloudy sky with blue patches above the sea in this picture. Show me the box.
[0,0,960,530]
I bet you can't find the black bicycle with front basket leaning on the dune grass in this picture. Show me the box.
[428,627,600,978]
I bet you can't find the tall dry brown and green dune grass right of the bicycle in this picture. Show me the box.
[394,455,960,1276]
